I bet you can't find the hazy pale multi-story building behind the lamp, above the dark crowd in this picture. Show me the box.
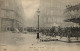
[36,0,79,27]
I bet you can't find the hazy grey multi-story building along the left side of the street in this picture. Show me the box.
[0,0,23,31]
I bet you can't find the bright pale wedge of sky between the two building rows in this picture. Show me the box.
[21,0,39,27]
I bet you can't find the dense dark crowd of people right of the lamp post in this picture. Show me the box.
[42,27,80,37]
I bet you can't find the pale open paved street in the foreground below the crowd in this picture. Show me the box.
[0,32,80,51]
